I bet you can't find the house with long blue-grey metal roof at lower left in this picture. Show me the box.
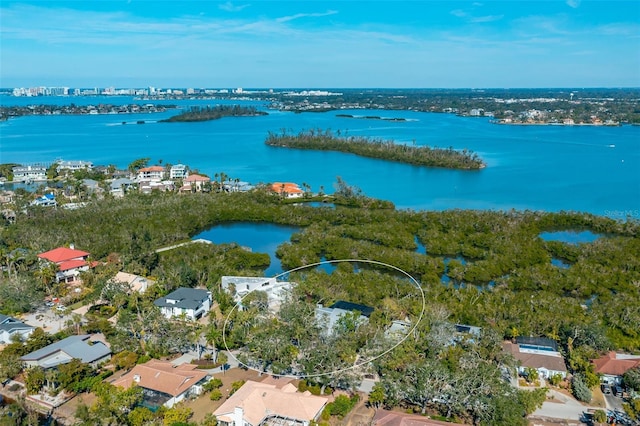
[20,334,111,369]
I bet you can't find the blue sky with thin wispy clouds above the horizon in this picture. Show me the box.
[0,0,640,89]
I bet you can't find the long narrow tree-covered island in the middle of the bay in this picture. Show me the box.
[265,129,486,170]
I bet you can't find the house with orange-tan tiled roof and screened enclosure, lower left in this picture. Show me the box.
[111,359,209,408]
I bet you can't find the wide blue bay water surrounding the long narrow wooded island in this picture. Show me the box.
[0,97,640,219]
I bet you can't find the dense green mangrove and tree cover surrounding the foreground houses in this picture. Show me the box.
[0,191,640,424]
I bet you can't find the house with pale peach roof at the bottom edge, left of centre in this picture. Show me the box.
[213,380,329,426]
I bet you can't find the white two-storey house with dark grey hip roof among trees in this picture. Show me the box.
[153,287,212,320]
